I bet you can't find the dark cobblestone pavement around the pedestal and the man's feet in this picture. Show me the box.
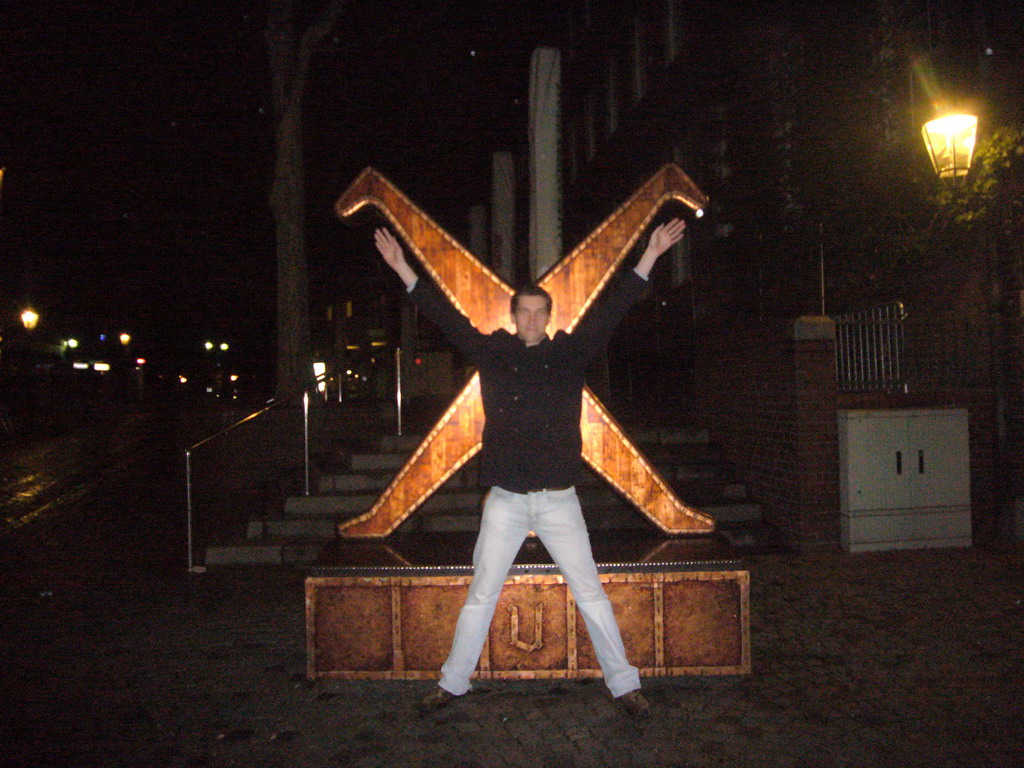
[0,417,1024,768]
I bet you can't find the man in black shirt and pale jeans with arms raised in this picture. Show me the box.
[375,219,685,718]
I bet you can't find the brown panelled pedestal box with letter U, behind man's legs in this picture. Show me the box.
[306,561,751,680]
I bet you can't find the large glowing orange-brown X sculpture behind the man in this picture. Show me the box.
[335,165,715,538]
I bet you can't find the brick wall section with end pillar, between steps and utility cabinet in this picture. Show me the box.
[694,317,840,551]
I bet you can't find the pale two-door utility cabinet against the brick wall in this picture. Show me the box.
[839,409,971,552]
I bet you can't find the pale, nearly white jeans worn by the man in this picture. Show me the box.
[438,485,640,696]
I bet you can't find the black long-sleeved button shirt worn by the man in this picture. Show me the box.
[410,269,647,494]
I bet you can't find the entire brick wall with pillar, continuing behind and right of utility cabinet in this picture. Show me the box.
[694,317,999,551]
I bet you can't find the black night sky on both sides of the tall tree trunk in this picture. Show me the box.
[0,0,558,358]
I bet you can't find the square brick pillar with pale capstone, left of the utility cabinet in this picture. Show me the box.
[787,315,840,552]
